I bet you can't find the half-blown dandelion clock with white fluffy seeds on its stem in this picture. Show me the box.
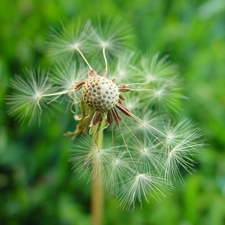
[7,18,203,224]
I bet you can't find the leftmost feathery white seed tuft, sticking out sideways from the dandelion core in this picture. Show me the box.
[6,69,56,124]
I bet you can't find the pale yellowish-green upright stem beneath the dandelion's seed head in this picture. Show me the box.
[91,123,104,225]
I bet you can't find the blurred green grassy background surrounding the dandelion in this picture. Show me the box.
[0,0,225,225]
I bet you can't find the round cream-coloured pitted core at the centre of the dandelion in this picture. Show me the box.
[82,75,120,112]
